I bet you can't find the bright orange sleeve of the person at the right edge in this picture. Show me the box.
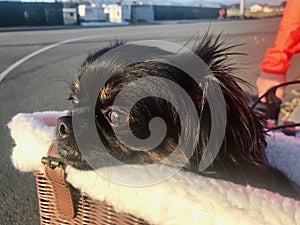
[260,0,300,74]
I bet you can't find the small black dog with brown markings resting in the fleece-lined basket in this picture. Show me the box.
[57,35,299,197]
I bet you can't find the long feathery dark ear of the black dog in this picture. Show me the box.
[193,34,266,169]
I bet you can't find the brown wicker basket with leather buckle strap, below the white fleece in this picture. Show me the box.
[35,144,149,225]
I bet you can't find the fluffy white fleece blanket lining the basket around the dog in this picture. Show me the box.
[8,112,300,225]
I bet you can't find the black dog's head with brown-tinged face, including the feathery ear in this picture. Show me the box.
[57,36,265,175]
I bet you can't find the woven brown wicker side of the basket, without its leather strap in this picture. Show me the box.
[34,172,149,225]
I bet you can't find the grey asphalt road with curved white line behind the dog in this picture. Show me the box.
[0,18,300,224]
